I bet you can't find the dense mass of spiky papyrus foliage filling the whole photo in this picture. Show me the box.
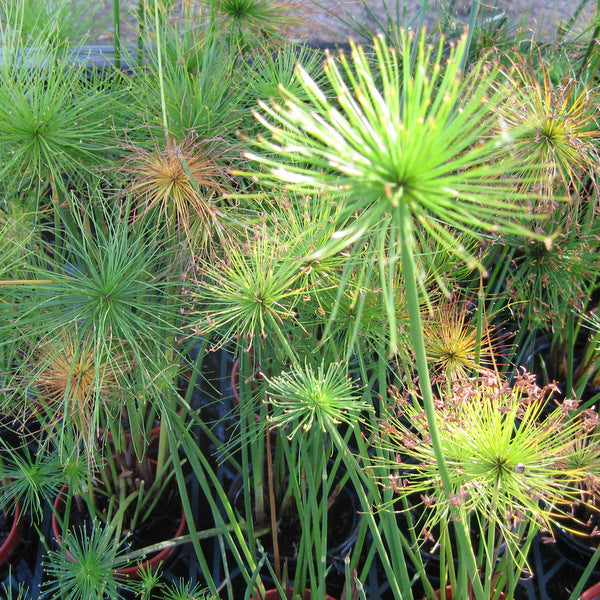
[0,0,600,600]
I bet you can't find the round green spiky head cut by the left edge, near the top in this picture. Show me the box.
[0,35,118,197]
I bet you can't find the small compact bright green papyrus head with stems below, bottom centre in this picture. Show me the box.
[266,362,369,598]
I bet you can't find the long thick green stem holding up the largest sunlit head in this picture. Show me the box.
[396,198,483,598]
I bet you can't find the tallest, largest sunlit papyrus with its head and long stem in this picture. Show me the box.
[240,32,550,597]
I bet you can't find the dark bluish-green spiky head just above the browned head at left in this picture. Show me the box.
[9,197,180,382]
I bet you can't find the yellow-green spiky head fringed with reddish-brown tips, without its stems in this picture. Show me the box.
[375,372,600,555]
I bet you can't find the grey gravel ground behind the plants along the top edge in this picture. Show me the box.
[95,0,597,45]
